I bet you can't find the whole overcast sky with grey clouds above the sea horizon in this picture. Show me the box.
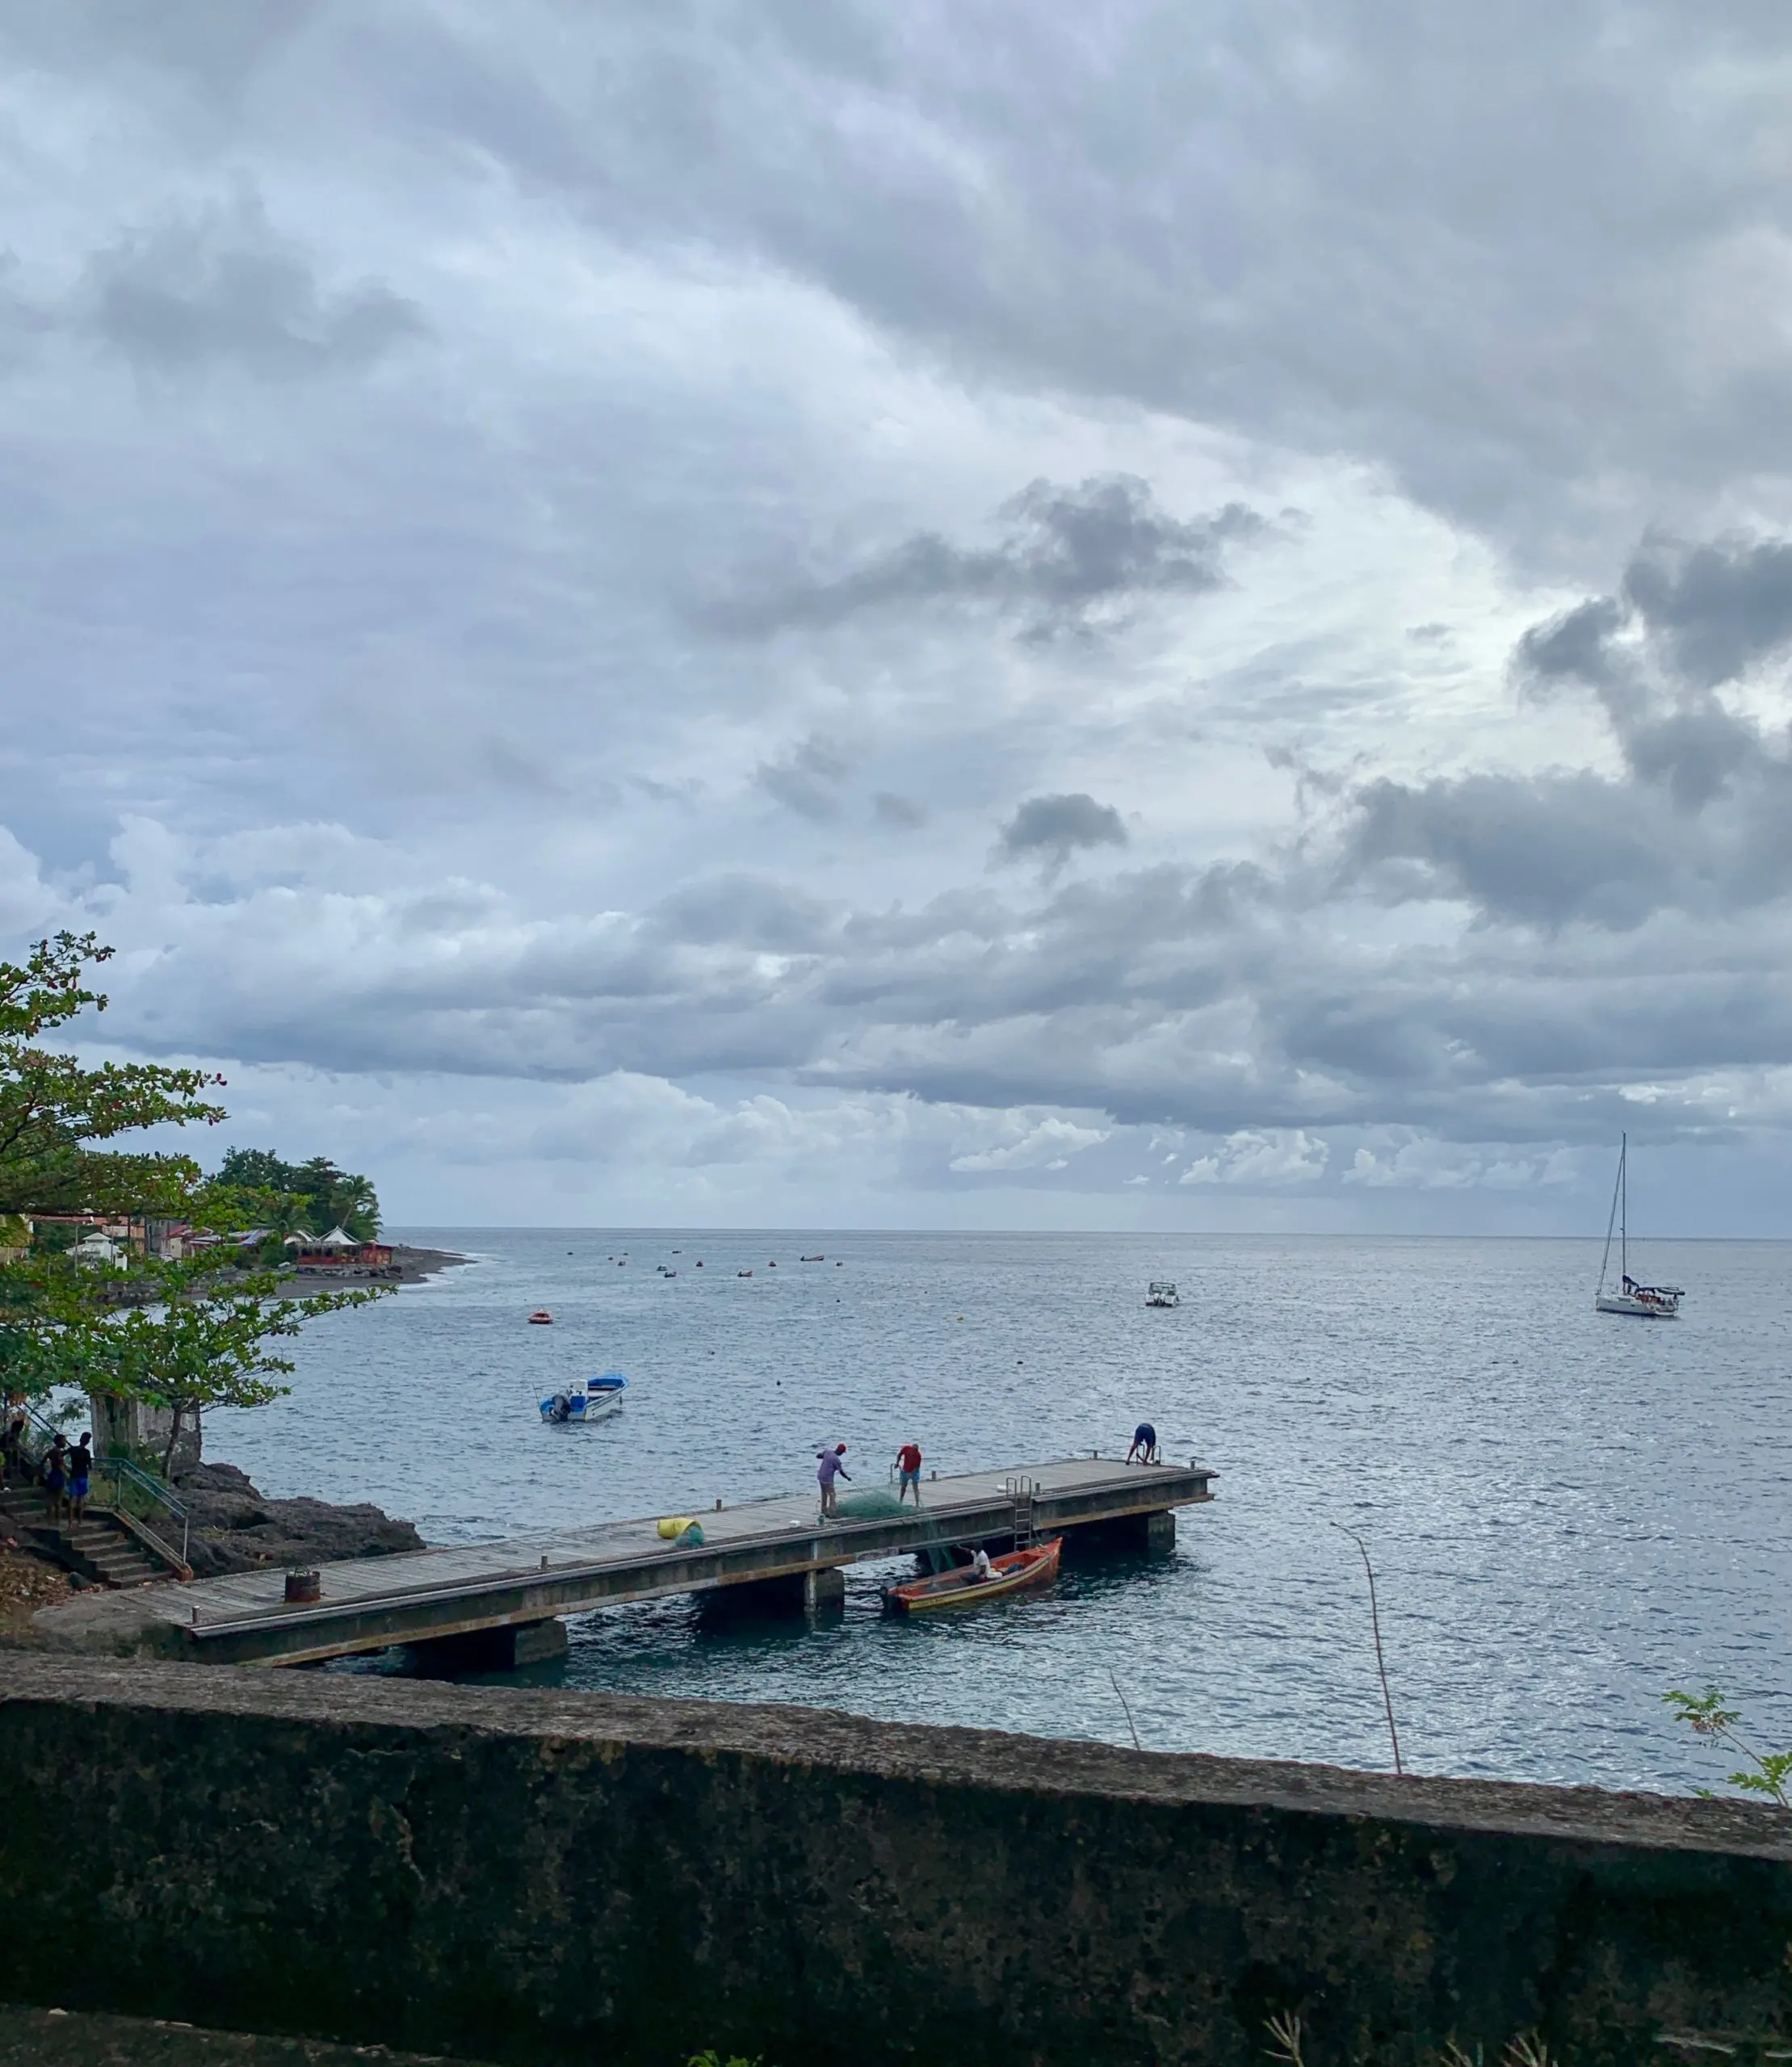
[0,0,1792,1234]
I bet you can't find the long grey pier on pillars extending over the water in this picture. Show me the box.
[40,1457,1215,1664]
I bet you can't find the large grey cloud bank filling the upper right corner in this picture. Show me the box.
[353,0,1792,558]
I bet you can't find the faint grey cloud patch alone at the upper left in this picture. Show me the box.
[74,195,426,380]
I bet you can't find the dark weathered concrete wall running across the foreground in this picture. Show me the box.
[0,1656,1792,2067]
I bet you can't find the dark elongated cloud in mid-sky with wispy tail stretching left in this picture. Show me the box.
[707,476,1263,639]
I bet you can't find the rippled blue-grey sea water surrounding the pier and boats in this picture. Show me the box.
[207,1230,1792,1788]
